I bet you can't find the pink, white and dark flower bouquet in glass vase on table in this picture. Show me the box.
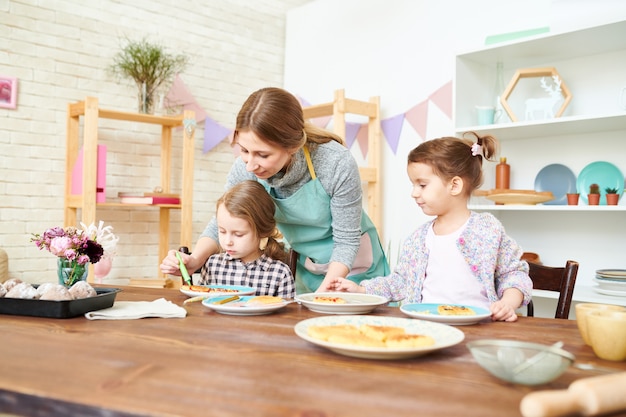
[31,222,118,287]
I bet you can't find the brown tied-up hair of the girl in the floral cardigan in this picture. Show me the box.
[408,132,498,195]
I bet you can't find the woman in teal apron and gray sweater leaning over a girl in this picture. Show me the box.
[161,88,389,294]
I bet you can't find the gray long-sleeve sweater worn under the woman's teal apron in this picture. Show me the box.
[201,141,363,268]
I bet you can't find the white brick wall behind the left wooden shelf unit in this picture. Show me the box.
[0,0,311,283]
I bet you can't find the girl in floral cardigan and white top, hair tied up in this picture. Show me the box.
[324,133,532,321]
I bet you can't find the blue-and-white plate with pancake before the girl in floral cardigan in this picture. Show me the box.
[400,303,491,326]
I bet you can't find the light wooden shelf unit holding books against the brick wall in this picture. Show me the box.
[64,97,195,282]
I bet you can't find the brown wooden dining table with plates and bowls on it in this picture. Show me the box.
[0,287,626,417]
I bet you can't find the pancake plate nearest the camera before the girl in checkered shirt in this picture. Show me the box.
[202,295,290,316]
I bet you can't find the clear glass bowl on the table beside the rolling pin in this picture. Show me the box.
[467,339,575,385]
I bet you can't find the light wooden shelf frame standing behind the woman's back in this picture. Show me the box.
[303,89,383,239]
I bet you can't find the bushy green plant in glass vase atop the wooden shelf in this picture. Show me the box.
[109,39,189,113]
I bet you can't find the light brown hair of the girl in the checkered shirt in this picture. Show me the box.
[216,180,287,262]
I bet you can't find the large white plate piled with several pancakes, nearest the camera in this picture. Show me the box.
[294,315,465,360]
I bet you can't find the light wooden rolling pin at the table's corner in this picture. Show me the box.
[520,372,626,417]
